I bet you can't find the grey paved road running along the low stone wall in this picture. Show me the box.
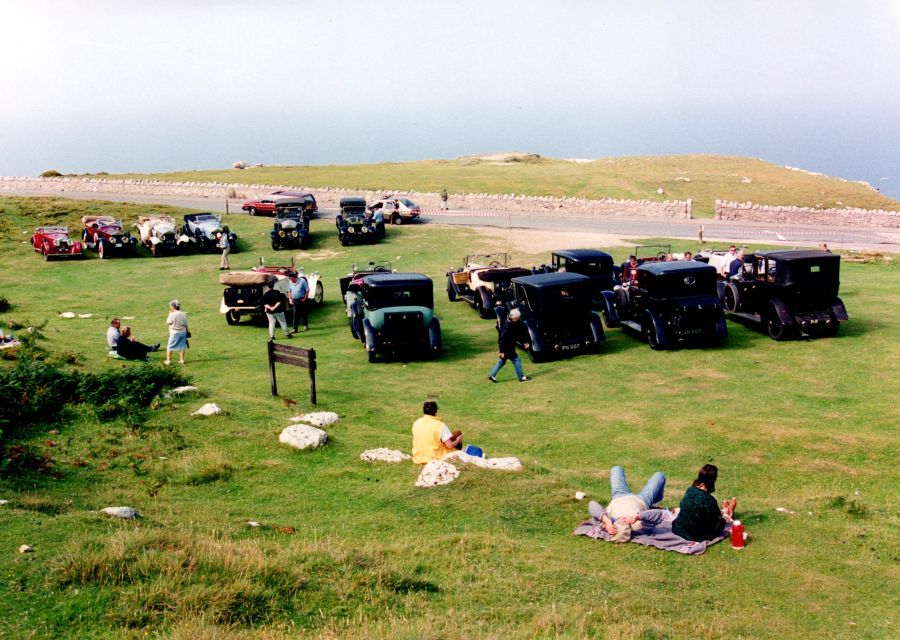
[0,186,900,253]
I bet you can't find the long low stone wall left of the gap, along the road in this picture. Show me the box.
[0,177,691,219]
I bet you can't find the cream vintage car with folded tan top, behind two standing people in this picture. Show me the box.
[219,258,325,325]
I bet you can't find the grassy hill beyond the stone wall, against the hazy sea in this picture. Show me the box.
[98,155,900,217]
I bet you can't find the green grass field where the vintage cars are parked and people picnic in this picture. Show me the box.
[0,196,900,640]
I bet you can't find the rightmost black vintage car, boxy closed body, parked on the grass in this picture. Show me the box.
[719,250,847,340]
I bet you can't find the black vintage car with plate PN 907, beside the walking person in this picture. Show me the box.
[494,273,606,362]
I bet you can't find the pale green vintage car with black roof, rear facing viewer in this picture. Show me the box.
[348,273,441,362]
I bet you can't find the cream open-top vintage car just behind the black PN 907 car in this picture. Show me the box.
[447,253,531,318]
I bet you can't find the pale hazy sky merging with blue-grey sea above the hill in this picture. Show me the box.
[0,0,900,198]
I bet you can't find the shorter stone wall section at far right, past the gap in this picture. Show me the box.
[716,200,900,229]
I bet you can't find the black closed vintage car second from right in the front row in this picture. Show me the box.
[603,261,728,349]
